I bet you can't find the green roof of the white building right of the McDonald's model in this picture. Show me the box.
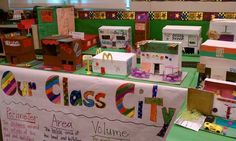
[140,41,180,54]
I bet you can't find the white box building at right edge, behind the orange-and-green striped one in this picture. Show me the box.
[209,19,236,42]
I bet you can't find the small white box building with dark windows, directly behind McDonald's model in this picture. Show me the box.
[98,26,132,48]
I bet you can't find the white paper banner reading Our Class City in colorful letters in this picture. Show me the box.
[0,66,187,141]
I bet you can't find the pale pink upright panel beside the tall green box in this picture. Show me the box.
[57,7,75,35]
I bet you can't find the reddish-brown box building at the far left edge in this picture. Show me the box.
[3,36,35,64]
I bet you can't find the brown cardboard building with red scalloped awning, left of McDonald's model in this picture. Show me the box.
[42,36,82,71]
